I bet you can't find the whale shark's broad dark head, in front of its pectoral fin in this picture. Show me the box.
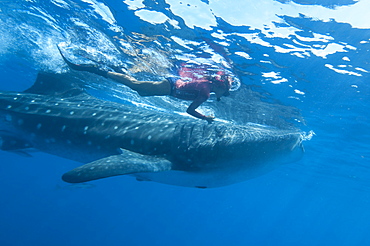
[166,123,303,171]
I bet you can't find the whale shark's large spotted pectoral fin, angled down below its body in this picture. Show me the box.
[62,150,172,183]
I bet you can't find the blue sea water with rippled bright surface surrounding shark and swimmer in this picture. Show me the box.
[0,0,370,246]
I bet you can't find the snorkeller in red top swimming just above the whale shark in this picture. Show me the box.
[58,47,237,123]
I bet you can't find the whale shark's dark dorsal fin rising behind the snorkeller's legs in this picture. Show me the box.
[24,72,84,97]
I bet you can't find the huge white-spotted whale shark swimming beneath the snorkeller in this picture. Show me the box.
[0,72,303,188]
